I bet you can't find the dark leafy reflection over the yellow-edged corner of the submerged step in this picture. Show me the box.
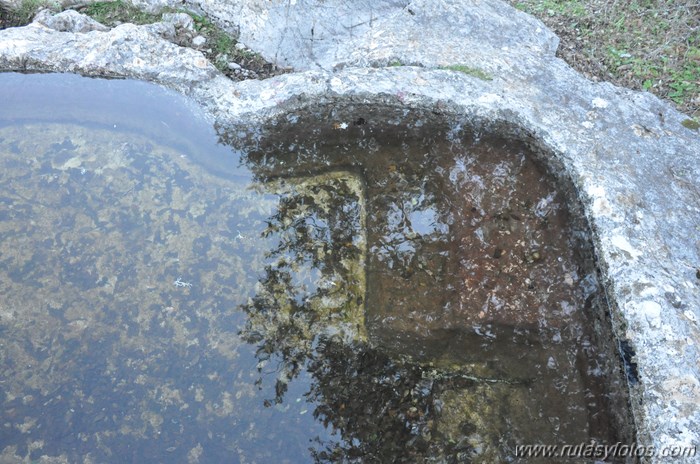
[243,173,365,402]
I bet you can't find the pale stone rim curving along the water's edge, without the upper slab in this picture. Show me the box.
[0,10,700,462]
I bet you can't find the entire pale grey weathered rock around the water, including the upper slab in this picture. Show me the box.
[0,0,700,462]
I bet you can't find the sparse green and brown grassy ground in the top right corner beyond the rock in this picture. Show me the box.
[508,0,700,119]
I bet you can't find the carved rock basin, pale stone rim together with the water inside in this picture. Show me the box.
[0,0,700,463]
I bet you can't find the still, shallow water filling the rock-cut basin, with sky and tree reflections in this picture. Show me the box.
[0,74,630,463]
